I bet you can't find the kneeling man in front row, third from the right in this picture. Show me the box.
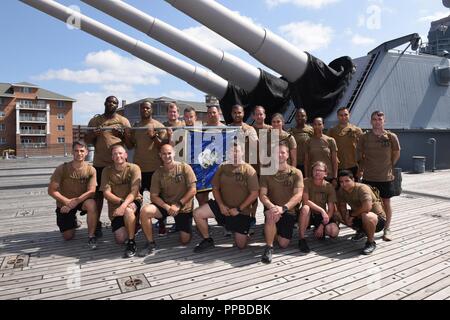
[259,144,303,263]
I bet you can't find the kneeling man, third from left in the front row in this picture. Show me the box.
[139,144,197,257]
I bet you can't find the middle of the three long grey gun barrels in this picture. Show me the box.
[81,0,261,91]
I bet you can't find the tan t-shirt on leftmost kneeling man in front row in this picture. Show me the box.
[50,161,97,208]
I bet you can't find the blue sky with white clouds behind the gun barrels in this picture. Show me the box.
[0,0,450,124]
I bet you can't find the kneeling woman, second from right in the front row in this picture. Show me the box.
[298,161,339,253]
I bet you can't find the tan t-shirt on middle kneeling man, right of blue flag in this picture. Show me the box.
[212,163,259,215]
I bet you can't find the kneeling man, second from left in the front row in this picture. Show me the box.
[100,144,142,258]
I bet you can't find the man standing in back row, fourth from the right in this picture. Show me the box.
[289,108,314,177]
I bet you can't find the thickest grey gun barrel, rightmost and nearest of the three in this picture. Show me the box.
[165,0,308,82]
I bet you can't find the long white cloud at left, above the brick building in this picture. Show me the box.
[33,50,166,86]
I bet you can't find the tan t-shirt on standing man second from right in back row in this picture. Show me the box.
[327,124,363,169]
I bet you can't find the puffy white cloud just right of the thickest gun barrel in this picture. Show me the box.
[278,21,334,51]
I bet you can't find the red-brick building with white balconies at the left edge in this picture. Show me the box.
[0,82,75,156]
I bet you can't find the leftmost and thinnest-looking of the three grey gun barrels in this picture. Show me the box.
[20,0,228,98]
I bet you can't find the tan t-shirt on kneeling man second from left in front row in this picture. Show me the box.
[100,163,142,221]
